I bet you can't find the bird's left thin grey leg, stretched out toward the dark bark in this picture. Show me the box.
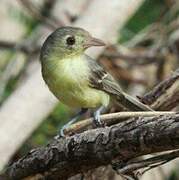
[60,108,88,137]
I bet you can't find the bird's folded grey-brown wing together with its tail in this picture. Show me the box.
[85,56,152,111]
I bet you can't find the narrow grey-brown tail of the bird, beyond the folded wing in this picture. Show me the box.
[116,93,154,111]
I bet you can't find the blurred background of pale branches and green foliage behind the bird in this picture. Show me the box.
[0,0,179,180]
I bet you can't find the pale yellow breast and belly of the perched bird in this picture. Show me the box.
[42,57,109,108]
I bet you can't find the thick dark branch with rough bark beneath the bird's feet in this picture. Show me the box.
[5,115,179,179]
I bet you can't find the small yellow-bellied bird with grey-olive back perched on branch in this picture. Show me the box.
[40,26,153,136]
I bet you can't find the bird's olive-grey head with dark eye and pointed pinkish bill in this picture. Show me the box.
[41,26,105,59]
